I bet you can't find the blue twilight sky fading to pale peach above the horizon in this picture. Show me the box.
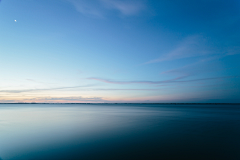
[0,0,240,103]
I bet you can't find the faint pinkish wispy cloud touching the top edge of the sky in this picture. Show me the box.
[68,0,145,18]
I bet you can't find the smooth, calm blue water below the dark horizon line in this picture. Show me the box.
[0,104,240,160]
